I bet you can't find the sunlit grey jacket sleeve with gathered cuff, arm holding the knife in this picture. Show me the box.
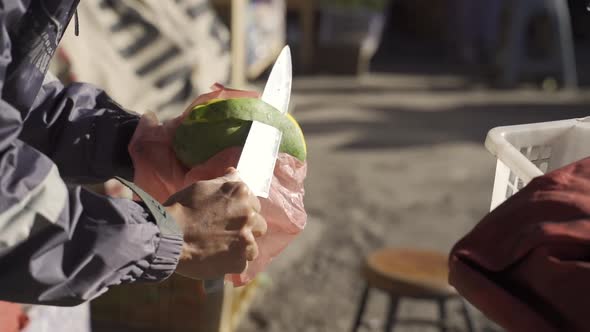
[0,140,182,305]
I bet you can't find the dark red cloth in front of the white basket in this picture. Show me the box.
[456,159,590,332]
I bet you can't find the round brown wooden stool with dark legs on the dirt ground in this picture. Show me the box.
[352,249,473,332]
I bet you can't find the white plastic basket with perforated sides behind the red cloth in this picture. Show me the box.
[485,117,590,210]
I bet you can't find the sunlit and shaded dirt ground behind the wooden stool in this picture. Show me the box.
[239,75,590,332]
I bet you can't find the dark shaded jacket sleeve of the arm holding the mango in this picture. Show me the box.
[20,81,139,183]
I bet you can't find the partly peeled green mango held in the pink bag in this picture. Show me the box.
[172,98,307,167]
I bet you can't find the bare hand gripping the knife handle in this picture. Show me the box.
[164,168,266,280]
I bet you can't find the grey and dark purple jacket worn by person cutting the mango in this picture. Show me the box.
[0,2,182,305]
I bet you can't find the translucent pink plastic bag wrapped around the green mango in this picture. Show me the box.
[129,84,307,286]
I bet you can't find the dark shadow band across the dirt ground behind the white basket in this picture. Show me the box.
[300,104,590,150]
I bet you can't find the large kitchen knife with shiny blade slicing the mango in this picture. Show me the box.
[204,46,292,293]
